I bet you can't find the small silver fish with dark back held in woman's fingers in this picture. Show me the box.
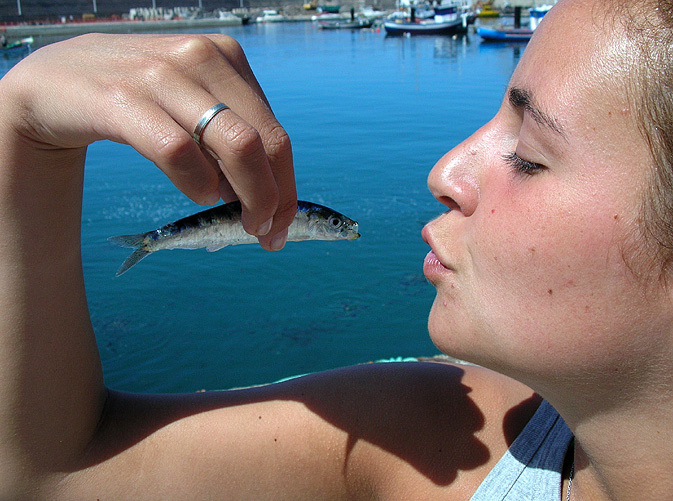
[108,200,360,277]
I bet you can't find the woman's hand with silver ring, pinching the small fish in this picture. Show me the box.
[3,34,296,250]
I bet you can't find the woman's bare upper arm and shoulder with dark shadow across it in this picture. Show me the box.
[61,362,539,499]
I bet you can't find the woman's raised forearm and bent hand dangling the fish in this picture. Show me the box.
[0,35,296,499]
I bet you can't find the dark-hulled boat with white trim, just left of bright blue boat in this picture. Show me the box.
[383,0,474,35]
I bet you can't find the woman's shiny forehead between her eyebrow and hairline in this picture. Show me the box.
[511,0,649,166]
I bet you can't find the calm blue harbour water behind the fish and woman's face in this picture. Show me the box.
[0,23,523,392]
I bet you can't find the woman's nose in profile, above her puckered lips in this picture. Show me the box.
[428,132,484,216]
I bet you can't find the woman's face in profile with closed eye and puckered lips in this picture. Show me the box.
[423,0,671,383]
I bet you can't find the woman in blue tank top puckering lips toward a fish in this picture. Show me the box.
[0,0,673,500]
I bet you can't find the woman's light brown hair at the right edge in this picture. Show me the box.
[604,0,673,274]
